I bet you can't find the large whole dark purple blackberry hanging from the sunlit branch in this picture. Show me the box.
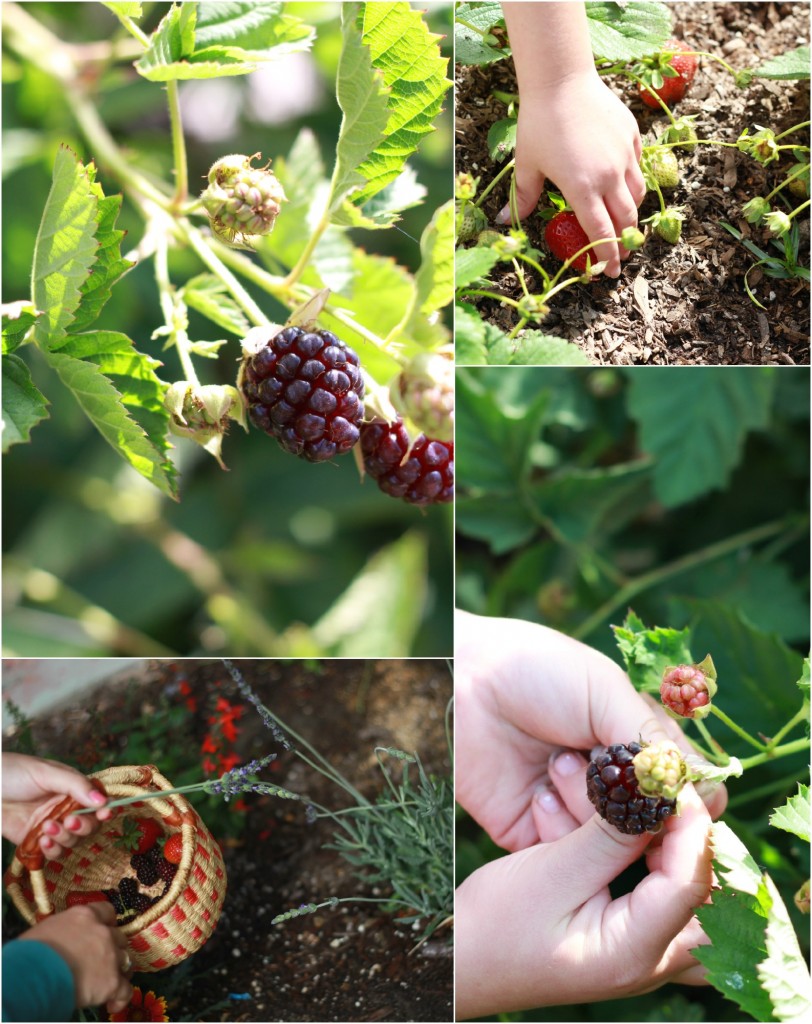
[241,327,364,462]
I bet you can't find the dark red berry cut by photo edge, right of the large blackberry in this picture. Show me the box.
[360,420,454,505]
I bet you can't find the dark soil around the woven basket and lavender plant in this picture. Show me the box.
[3,660,453,1021]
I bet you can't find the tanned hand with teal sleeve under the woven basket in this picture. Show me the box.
[20,903,132,1013]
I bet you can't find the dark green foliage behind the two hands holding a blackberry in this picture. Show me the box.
[457,368,809,1021]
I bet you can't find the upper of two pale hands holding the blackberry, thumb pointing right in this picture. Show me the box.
[455,611,727,850]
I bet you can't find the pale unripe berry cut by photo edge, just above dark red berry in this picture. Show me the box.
[390,352,454,441]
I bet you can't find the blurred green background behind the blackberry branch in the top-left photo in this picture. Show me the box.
[2,3,453,656]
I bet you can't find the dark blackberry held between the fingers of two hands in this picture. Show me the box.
[587,743,677,836]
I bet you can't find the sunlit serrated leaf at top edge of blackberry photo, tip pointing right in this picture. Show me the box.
[195,0,314,61]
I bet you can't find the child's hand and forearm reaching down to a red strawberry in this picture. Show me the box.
[497,2,645,278]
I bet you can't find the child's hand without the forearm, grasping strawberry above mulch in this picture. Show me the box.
[497,70,646,278]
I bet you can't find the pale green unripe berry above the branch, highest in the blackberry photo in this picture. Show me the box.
[201,154,287,244]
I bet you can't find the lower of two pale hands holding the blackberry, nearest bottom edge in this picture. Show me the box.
[455,774,712,1019]
